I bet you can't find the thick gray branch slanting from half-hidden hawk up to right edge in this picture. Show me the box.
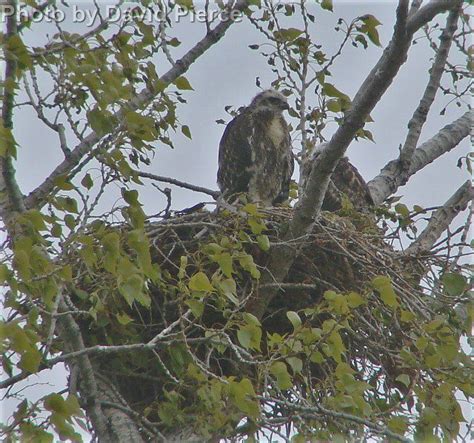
[368,110,474,205]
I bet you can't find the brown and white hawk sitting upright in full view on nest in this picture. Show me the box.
[217,90,294,206]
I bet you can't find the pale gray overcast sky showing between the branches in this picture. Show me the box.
[4,1,469,438]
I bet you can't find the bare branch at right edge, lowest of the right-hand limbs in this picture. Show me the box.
[405,180,474,255]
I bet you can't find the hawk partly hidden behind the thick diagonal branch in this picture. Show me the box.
[301,143,374,212]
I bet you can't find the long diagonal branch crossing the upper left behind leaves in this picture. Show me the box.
[25,0,247,212]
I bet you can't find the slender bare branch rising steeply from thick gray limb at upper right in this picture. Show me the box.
[400,7,460,170]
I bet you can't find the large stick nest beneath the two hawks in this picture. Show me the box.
[71,208,431,424]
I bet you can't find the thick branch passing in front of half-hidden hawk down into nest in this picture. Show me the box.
[247,0,418,318]
